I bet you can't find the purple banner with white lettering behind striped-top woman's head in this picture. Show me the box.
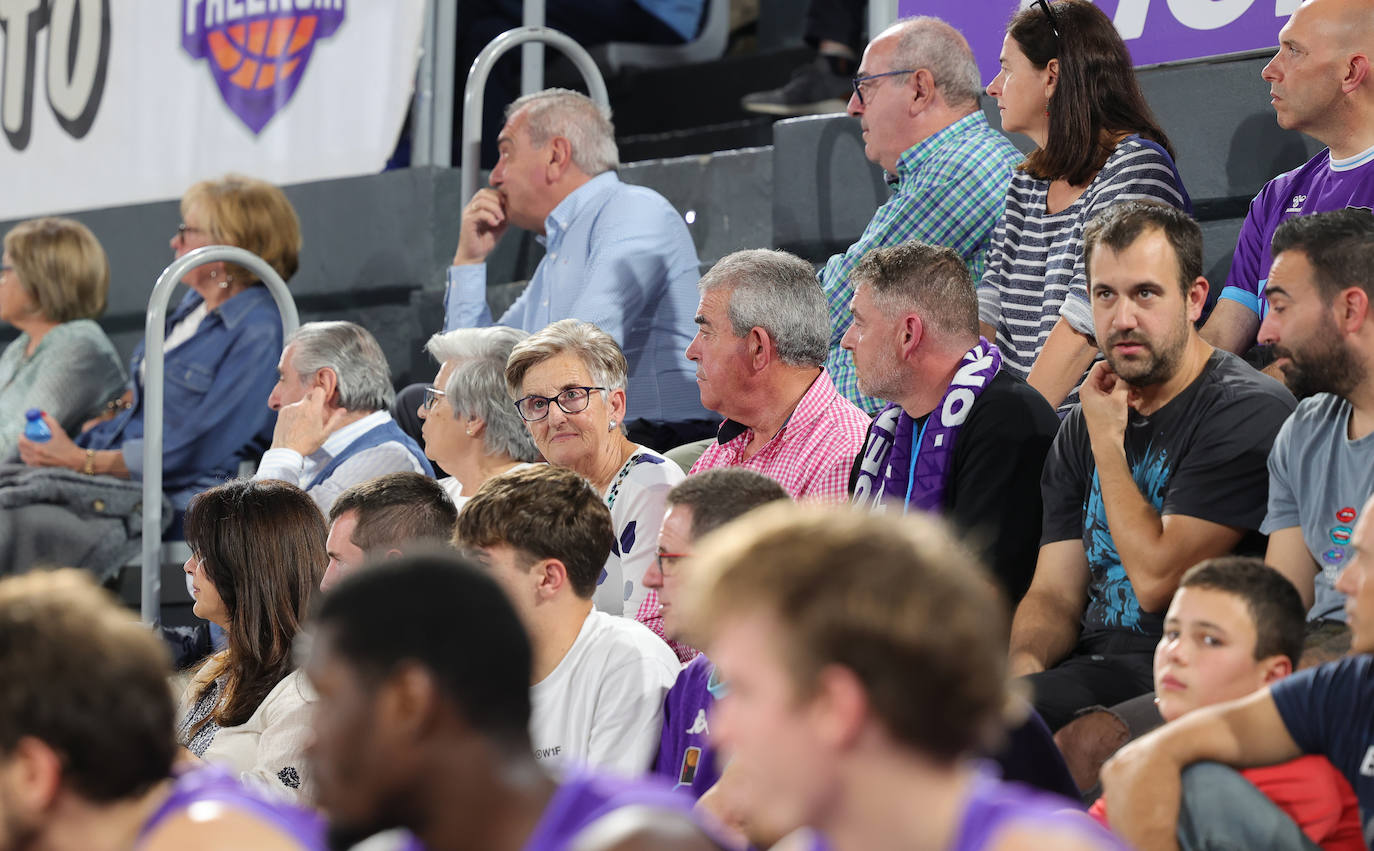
[897,0,1297,84]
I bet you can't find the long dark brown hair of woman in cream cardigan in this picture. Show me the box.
[185,480,328,727]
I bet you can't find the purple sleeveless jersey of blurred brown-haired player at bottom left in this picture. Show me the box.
[135,766,328,851]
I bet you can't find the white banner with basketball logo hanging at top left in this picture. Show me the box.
[0,0,425,220]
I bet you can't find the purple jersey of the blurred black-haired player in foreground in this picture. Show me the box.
[523,774,692,851]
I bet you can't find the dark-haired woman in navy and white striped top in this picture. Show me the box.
[978,0,1191,406]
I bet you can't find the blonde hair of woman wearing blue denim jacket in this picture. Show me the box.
[181,175,301,280]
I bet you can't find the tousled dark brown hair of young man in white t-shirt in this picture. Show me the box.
[453,463,616,599]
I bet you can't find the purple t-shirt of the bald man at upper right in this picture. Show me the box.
[1220,148,1374,328]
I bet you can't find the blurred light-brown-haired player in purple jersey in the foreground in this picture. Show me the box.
[684,506,1121,851]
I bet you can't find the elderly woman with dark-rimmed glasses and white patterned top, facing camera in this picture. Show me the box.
[506,319,687,656]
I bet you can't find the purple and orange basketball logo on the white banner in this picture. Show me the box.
[181,0,344,133]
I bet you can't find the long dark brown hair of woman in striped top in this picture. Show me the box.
[1007,0,1173,186]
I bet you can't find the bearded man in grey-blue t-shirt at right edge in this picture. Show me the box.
[1260,209,1374,635]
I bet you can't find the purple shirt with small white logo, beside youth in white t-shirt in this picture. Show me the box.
[653,654,724,797]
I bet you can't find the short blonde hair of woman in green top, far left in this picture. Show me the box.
[4,217,110,322]
